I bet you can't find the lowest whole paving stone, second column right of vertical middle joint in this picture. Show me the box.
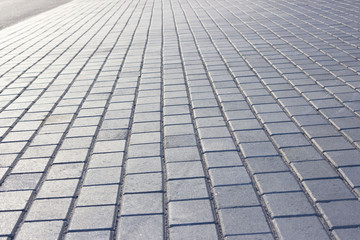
[219,207,271,237]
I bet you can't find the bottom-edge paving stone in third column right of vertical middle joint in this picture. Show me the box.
[274,216,329,240]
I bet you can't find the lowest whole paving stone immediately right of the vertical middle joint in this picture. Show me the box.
[168,200,215,227]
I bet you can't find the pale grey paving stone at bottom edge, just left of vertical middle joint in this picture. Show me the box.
[116,215,164,240]
